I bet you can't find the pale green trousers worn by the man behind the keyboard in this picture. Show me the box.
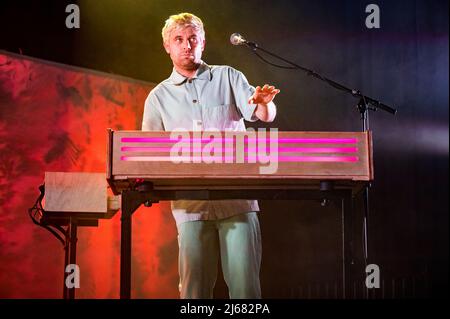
[178,212,261,299]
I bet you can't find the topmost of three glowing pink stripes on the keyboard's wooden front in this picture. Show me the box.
[120,137,358,144]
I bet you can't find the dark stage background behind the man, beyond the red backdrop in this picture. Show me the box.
[0,0,449,298]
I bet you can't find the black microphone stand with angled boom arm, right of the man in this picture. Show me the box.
[242,40,397,298]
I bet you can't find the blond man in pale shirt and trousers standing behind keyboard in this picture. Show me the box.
[142,13,279,298]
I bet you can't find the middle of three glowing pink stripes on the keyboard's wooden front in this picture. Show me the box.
[120,146,358,153]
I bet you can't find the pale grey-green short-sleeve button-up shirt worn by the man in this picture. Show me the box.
[142,63,259,225]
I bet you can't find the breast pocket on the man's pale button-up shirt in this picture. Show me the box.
[202,103,242,131]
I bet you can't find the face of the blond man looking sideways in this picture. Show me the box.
[164,26,205,71]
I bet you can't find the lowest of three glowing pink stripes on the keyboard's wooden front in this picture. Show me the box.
[120,156,359,164]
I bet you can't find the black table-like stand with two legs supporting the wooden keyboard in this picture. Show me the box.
[120,183,354,299]
